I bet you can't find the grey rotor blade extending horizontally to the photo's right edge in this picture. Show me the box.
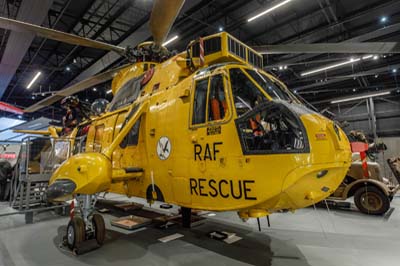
[252,42,400,54]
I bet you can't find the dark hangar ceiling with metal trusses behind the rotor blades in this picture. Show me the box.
[0,0,400,118]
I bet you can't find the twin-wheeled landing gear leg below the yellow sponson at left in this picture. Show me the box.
[64,195,106,254]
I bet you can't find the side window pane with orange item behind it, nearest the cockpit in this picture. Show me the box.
[208,75,228,121]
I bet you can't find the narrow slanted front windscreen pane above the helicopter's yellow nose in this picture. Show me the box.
[246,69,295,102]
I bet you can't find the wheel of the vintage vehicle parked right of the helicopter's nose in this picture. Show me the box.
[354,186,390,215]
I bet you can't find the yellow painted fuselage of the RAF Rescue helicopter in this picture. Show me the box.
[51,34,351,217]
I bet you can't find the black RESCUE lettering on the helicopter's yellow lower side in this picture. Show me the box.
[189,178,257,200]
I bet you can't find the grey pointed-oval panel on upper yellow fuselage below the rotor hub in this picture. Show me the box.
[109,75,143,112]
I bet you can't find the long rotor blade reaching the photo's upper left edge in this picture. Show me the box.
[0,17,125,54]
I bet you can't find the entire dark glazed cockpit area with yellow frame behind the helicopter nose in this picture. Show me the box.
[229,68,308,154]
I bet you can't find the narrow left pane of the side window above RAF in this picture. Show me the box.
[192,78,208,125]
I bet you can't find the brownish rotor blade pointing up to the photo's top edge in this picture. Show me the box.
[150,0,185,46]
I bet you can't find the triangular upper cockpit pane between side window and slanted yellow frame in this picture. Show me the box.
[229,68,267,116]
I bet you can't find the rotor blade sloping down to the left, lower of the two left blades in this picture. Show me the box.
[24,64,129,113]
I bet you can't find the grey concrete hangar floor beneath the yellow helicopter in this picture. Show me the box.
[0,195,400,266]
